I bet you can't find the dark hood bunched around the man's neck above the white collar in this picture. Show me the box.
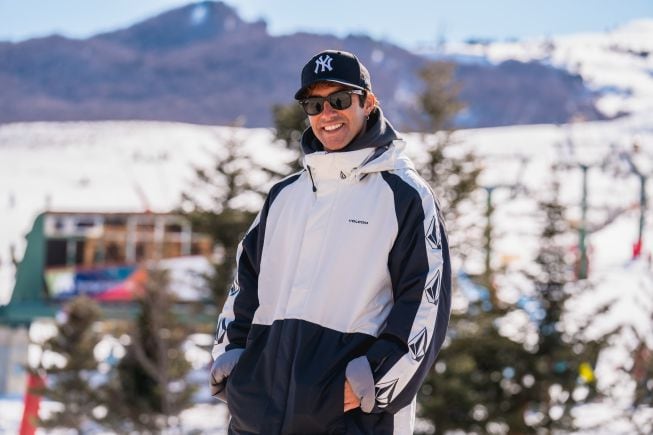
[302,107,399,155]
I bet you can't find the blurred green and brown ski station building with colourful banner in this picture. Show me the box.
[0,212,213,394]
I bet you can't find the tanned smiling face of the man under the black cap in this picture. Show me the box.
[308,83,374,151]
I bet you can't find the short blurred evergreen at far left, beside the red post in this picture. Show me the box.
[35,296,106,434]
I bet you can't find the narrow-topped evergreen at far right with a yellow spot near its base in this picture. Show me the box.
[526,181,605,431]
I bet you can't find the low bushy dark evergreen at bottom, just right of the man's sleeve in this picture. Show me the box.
[418,293,534,434]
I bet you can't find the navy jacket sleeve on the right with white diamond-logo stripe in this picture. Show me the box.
[348,169,451,413]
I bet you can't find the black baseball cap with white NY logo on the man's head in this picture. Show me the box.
[295,50,372,100]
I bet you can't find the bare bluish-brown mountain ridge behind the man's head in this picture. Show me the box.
[0,1,603,129]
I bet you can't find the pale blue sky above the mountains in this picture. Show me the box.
[0,0,653,49]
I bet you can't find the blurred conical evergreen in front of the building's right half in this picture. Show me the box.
[107,269,196,433]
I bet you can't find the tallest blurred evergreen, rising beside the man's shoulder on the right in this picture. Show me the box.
[418,62,526,433]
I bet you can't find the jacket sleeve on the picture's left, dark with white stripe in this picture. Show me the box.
[209,207,266,400]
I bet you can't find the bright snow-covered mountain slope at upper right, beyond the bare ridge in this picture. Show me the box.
[436,19,653,122]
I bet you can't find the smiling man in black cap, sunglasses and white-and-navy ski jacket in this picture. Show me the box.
[210,50,451,435]
